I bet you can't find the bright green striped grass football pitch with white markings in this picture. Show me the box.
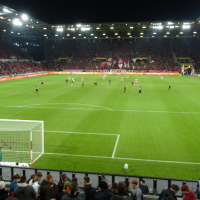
[0,75,200,180]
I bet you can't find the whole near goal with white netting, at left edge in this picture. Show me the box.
[0,119,44,166]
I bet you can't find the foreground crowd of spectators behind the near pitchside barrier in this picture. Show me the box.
[0,171,196,200]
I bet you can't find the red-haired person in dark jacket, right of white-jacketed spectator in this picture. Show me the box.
[40,174,53,200]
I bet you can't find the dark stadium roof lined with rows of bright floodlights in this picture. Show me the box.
[0,5,200,39]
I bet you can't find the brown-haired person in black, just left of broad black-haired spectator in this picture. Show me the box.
[83,176,96,200]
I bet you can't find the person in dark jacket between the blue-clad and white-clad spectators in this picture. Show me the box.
[13,176,36,200]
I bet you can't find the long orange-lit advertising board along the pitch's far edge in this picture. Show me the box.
[0,72,179,81]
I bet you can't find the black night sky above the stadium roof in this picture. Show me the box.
[0,0,200,24]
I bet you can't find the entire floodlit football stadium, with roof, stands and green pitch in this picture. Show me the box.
[0,2,200,200]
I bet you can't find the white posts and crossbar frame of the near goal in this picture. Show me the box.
[0,119,44,167]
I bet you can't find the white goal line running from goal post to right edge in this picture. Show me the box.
[43,153,200,165]
